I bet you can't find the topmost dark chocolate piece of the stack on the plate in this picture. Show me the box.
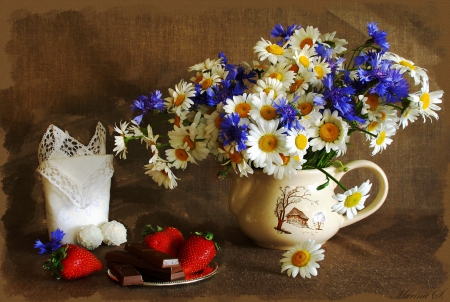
[125,243,180,268]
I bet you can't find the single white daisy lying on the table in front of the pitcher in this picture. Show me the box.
[280,239,325,278]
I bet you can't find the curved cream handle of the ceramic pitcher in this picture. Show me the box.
[337,160,389,228]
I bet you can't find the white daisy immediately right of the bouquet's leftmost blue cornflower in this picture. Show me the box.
[164,80,195,115]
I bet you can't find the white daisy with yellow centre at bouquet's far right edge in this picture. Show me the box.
[408,85,444,122]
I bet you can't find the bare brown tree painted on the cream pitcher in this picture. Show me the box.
[274,186,311,234]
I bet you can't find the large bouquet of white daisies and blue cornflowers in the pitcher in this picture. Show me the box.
[114,23,443,191]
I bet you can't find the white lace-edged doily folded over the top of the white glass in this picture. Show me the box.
[37,123,114,209]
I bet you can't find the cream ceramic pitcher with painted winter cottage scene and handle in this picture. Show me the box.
[229,160,388,250]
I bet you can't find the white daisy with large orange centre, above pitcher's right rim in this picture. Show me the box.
[310,109,348,155]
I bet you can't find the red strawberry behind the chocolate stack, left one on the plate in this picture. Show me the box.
[142,224,184,257]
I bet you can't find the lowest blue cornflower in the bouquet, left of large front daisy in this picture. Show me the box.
[219,113,248,152]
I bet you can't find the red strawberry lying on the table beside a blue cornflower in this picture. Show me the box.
[44,244,103,280]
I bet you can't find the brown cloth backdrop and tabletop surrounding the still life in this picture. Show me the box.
[0,0,450,301]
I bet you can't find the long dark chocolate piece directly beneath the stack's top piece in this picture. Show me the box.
[105,250,181,275]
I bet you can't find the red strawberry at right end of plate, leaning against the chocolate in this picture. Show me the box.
[178,232,220,275]
